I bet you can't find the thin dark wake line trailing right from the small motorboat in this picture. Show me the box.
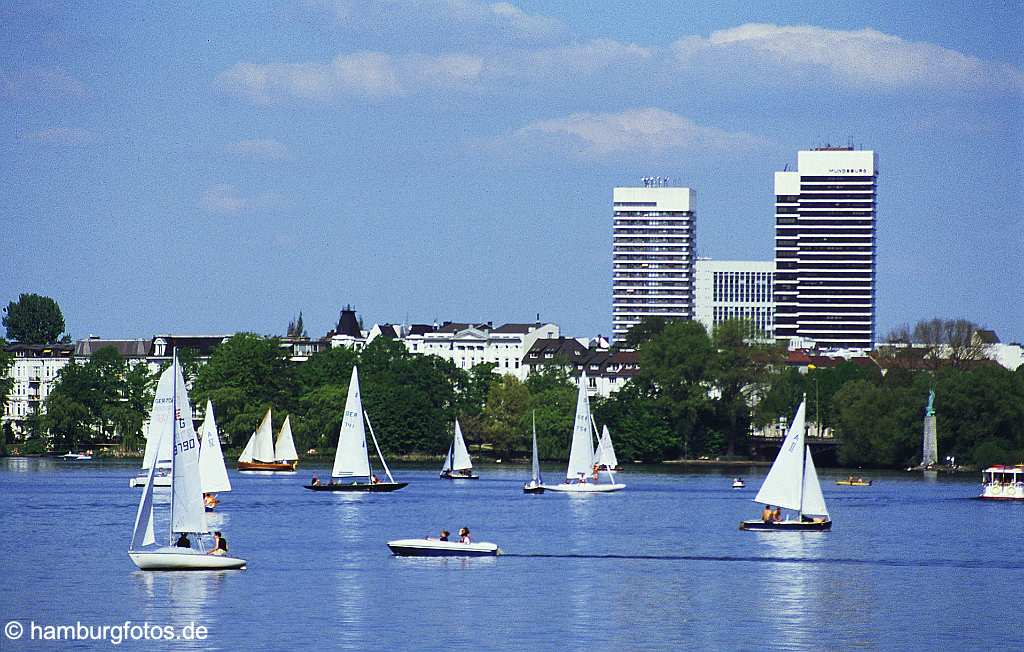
[502,553,1024,570]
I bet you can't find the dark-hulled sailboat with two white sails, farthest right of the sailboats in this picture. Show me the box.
[739,396,831,531]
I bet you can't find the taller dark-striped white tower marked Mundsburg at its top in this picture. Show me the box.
[774,146,878,350]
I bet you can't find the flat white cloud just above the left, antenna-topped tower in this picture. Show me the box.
[506,107,765,158]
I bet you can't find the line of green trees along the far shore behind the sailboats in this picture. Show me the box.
[0,290,1024,468]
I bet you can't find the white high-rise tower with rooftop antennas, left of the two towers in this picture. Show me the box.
[611,178,696,340]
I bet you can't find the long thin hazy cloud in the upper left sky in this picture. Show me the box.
[217,52,483,103]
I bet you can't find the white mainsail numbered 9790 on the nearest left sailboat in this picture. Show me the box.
[171,360,209,532]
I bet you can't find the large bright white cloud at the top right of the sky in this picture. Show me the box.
[673,23,1024,90]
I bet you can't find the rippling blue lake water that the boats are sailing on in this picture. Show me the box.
[0,459,1024,652]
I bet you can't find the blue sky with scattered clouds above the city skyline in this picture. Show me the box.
[0,0,1024,341]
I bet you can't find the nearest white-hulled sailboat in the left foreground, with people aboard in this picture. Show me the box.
[128,355,246,570]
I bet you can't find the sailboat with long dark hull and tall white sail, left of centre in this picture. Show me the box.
[305,366,409,492]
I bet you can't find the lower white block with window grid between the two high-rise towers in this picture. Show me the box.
[693,258,775,339]
